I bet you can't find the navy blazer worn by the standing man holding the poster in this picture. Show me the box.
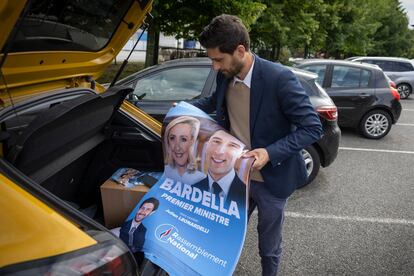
[194,55,322,198]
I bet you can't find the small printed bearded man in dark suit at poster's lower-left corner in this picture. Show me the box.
[119,197,159,263]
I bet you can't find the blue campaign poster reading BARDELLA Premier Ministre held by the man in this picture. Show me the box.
[116,102,253,275]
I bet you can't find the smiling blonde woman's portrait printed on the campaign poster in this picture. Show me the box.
[164,116,206,185]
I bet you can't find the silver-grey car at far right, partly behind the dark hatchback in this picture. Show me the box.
[352,57,414,99]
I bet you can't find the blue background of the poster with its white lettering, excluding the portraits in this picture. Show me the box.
[123,102,247,275]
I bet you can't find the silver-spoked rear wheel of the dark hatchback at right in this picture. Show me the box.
[359,109,392,139]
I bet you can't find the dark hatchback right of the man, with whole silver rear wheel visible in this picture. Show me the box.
[297,59,402,139]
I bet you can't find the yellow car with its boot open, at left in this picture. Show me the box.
[0,0,163,275]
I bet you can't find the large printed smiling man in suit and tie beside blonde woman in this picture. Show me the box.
[193,130,246,211]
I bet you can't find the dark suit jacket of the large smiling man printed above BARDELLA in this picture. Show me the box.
[192,175,246,210]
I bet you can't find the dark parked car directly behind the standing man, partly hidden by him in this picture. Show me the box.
[118,58,340,188]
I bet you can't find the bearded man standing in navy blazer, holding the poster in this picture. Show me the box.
[195,15,322,275]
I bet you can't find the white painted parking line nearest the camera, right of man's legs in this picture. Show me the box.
[285,212,414,226]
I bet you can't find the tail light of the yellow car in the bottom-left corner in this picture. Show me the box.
[6,244,137,276]
